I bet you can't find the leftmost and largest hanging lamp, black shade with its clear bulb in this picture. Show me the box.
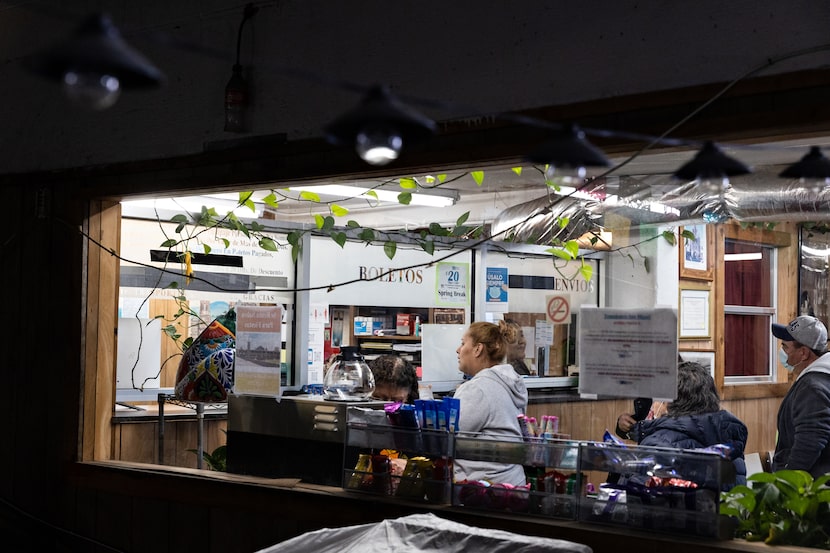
[26,14,164,110]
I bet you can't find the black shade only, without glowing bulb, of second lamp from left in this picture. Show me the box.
[324,86,437,146]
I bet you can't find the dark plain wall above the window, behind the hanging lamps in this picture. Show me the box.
[0,0,830,173]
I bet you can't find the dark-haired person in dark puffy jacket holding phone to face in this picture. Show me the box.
[617,361,748,484]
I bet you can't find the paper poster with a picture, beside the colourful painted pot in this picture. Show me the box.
[233,305,282,397]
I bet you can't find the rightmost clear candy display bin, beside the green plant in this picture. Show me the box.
[579,442,735,539]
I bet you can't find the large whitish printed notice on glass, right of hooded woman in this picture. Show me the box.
[578,307,677,399]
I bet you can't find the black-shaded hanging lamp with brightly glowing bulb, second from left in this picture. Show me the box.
[324,86,436,165]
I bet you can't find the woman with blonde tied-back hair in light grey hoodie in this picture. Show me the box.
[453,321,527,486]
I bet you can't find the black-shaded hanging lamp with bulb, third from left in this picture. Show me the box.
[526,124,611,184]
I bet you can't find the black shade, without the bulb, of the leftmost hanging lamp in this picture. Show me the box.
[28,14,164,88]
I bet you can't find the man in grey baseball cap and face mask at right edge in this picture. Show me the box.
[772,315,830,478]
